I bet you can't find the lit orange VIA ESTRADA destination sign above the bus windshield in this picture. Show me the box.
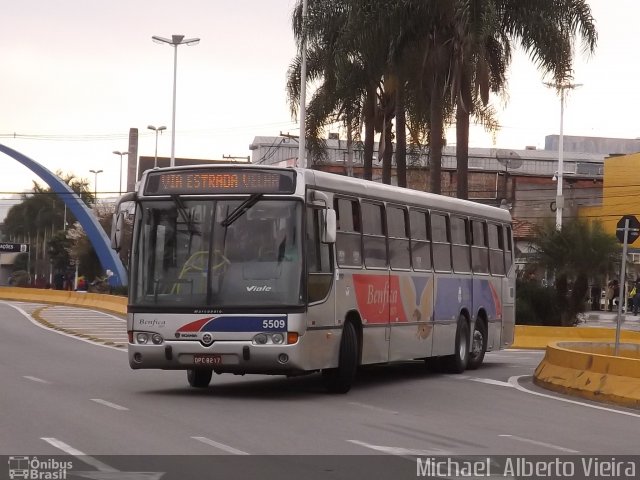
[144,168,295,195]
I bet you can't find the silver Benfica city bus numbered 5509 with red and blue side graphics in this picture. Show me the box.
[112,165,515,393]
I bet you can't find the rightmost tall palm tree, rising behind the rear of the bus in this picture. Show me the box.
[451,0,597,198]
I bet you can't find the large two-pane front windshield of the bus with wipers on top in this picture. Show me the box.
[130,196,303,308]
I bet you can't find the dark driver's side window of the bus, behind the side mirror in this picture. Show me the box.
[306,207,333,303]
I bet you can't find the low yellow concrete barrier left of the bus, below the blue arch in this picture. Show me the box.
[0,287,127,315]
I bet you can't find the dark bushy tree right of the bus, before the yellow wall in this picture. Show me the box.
[531,218,620,325]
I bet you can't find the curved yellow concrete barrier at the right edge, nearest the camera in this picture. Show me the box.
[533,342,640,408]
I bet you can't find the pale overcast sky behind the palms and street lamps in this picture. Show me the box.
[0,0,640,215]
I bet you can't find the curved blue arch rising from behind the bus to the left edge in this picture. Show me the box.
[0,144,127,287]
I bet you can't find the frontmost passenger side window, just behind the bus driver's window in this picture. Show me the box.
[334,198,362,267]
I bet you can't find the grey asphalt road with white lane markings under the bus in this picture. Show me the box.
[0,302,640,478]
